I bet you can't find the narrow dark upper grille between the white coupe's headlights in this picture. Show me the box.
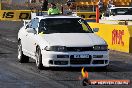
[67,47,93,52]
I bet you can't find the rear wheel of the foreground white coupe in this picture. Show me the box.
[18,41,29,63]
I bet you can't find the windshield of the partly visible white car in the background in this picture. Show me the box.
[111,8,132,15]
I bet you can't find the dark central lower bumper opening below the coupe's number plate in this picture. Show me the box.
[70,55,91,65]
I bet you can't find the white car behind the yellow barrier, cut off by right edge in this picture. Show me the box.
[102,7,132,21]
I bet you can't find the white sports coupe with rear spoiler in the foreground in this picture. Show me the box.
[18,16,109,69]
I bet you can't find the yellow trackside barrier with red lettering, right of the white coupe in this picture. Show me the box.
[89,23,132,53]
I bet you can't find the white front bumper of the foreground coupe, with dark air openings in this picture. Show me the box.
[42,51,109,67]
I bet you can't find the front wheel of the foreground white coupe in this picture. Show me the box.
[36,47,43,70]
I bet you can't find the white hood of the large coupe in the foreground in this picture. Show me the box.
[43,33,106,47]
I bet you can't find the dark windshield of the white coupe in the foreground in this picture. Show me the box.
[39,18,93,33]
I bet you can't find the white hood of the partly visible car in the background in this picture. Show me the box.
[108,15,132,20]
